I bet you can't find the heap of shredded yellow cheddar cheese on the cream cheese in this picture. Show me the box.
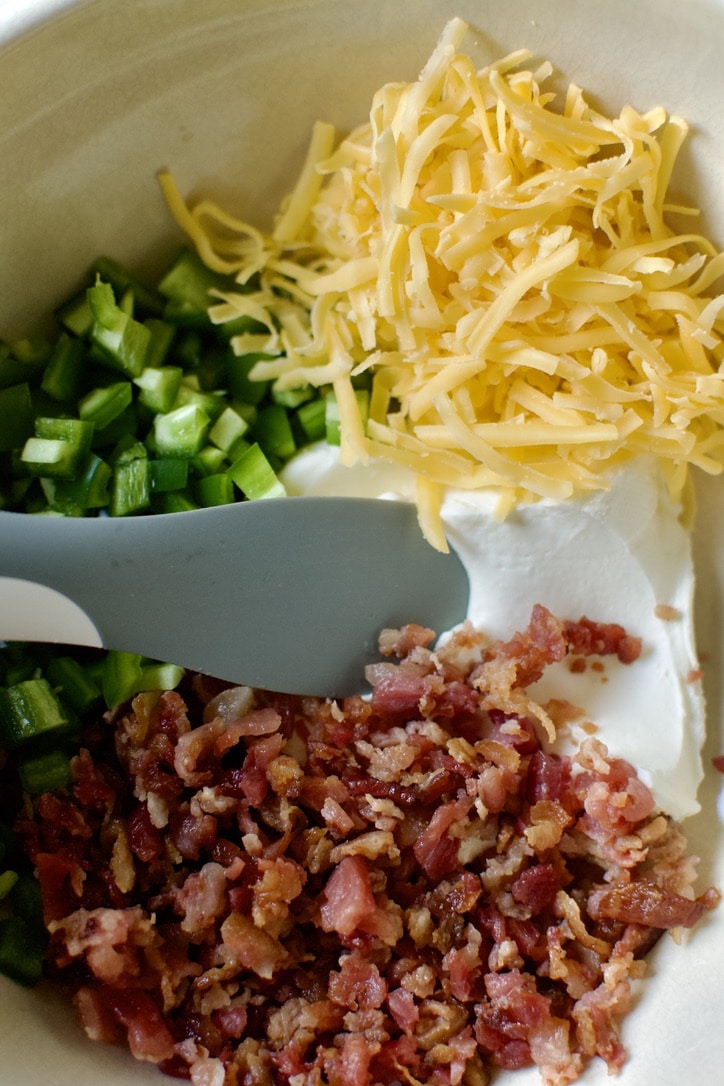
[161,18,724,548]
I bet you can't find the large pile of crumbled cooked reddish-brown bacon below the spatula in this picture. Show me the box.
[18,607,717,1086]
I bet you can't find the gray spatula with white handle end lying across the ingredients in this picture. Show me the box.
[0,497,469,696]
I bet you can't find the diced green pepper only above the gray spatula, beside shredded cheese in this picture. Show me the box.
[0,249,356,516]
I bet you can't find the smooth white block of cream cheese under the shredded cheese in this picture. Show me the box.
[283,444,704,819]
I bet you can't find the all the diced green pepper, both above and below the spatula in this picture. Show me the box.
[0,248,366,984]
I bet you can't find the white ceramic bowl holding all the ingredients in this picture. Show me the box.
[0,0,724,1086]
